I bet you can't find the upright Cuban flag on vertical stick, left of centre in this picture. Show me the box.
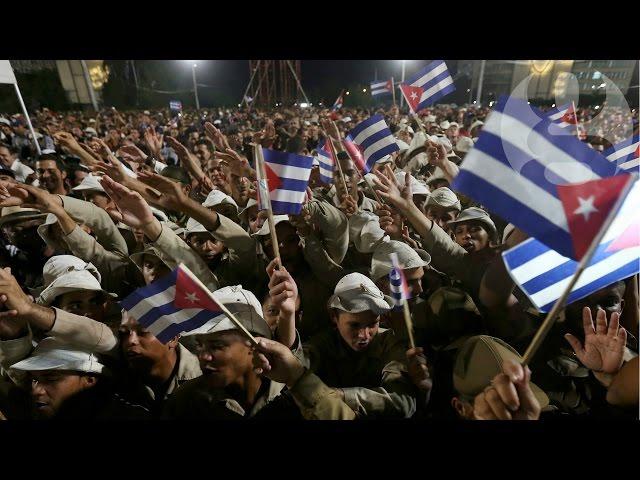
[258,148,313,215]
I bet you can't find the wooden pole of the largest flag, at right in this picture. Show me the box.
[522,175,637,365]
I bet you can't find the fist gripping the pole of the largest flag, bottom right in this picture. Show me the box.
[473,360,541,420]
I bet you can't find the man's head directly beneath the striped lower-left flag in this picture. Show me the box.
[118,312,179,376]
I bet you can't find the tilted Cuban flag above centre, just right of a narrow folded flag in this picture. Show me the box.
[344,115,400,173]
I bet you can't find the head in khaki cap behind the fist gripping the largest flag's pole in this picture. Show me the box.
[451,335,549,420]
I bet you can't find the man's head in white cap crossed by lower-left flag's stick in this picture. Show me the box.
[187,285,272,388]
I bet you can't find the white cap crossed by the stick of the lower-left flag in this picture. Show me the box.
[182,285,271,338]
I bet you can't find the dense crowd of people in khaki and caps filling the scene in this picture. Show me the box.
[0,97,639,420]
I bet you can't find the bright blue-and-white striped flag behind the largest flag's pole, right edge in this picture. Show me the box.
[502,175,640,312]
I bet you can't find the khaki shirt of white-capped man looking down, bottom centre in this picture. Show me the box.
[304,329,418,418]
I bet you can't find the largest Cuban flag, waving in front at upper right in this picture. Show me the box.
[452,98,626,259]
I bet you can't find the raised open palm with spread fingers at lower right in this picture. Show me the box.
[565,307,627,374]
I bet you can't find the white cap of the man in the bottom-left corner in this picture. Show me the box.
[11,337,105,373]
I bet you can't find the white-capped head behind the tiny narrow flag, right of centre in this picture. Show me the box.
[371,240,431,305]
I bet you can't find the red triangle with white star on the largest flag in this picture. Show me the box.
[557,175,631,260]
